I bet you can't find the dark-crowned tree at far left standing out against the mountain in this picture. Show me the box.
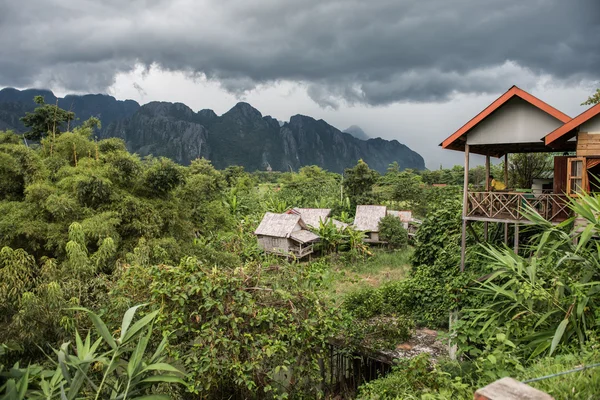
[21,96,75,140]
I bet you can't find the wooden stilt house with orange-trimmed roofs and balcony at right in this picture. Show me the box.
[441,86,600,270]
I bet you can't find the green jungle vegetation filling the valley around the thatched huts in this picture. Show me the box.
[0,101,600,399]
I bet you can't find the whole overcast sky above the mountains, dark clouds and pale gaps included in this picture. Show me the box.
[0,0,600,168]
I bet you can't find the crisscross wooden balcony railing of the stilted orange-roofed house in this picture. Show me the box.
[466,192,571,222]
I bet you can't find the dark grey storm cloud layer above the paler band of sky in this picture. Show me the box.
[0,0,600,107]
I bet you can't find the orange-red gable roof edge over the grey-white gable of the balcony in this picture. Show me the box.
[440,86,571,150]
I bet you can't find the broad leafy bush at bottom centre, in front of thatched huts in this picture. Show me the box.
[113,257,340,398]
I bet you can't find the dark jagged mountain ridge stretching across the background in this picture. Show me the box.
[0,88,425,172]
